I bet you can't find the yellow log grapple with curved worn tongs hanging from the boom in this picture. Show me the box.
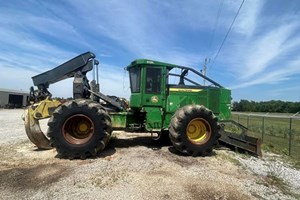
[23,98,61,149]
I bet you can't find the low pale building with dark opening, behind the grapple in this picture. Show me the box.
[0,88,29,108]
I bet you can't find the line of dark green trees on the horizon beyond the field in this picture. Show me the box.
[232,99,300,113]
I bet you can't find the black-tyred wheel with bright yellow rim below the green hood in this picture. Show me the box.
[169,105,220,156]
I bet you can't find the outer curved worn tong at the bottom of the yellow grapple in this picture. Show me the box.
[24,108,52,149]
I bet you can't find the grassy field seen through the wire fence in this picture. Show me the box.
[232,112,300,159]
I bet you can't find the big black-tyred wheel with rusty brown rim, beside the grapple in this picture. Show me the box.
[48,99,112,159]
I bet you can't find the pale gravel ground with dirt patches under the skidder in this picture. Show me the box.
[0,110,300,200]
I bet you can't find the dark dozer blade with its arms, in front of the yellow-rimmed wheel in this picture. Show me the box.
[219,120,262,156]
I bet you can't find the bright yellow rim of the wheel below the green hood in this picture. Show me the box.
[186,118,211,144]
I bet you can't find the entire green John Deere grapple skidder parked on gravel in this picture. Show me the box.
[24,52,261,159]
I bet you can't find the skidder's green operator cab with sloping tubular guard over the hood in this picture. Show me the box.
[126,59,223,109]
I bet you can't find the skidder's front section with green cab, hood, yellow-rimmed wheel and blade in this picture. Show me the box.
[109,59,261,156]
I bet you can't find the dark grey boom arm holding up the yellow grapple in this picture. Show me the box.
[30,51,122,110]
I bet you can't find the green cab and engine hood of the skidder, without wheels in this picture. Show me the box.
[126,60,231,131]
